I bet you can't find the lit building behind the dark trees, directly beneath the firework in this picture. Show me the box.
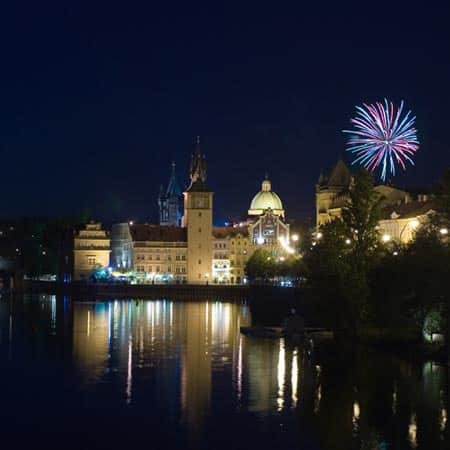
[316,160,435,243]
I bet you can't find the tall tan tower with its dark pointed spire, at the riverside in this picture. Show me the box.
[184,137,213,284]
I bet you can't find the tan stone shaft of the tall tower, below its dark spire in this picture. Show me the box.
[184,191,213,284]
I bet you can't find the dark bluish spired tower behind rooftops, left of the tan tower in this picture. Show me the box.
[158,162,183,227]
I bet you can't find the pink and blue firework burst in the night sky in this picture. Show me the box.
[343,99,419,181]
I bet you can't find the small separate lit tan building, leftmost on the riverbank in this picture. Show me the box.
[73,222,111,280]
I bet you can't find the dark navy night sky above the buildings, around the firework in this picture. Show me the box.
[0,0,450,222]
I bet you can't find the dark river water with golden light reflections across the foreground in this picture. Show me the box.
[0,296,449,450]
